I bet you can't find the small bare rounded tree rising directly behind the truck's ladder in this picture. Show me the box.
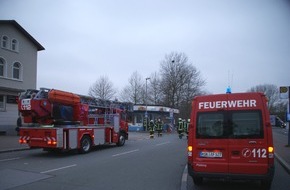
[89,76,116,100]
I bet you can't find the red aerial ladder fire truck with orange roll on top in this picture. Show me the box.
[18,88,131,153]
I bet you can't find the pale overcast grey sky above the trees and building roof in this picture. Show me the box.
[0,0,290,94]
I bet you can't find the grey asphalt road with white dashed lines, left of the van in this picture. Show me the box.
[0,134,186,190]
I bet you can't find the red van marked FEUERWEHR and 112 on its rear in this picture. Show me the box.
[188,93,275,189]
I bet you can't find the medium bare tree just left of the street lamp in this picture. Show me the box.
[120,71,145,104]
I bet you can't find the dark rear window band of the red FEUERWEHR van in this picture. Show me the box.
[196,111,264,139]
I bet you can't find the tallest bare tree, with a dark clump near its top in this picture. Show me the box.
[160,52,205,111]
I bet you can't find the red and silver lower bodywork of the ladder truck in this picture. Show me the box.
[19,126,119,150]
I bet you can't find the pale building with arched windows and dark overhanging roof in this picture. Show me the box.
[0,20,44,135]
